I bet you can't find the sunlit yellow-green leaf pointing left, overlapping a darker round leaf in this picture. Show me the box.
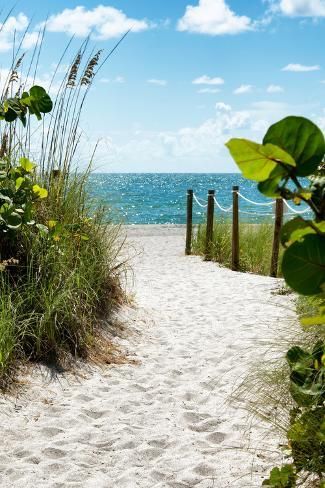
[226,139,296,181]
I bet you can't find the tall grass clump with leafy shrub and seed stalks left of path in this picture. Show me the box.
[0,32,123,386]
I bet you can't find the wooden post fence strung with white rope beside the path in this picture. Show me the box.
[185,186,311,277]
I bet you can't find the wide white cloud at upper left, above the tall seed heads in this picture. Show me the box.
[46,5,152,40]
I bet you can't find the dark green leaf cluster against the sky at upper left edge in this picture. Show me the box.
[0,85,53,126]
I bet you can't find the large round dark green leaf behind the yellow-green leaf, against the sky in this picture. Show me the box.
[263,116,325,176]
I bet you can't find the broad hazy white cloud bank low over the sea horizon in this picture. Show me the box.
[99,102,250,171]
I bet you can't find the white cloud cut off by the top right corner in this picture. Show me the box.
[271,0,325,17]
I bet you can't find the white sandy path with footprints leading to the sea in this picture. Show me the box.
[0,226,294,488]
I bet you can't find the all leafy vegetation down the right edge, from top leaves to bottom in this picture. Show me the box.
[227,117,325,488]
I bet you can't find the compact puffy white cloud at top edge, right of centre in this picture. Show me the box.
[177,0,253,36]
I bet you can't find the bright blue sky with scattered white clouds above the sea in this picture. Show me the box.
[0,0,325,172]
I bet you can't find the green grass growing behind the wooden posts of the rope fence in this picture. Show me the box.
[193,221,273,275]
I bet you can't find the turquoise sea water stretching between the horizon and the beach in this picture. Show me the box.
[89,173,286,224]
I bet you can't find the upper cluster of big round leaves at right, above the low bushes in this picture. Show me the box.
[227,117,325,308]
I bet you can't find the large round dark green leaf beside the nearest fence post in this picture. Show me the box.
[282,234,325,295]
